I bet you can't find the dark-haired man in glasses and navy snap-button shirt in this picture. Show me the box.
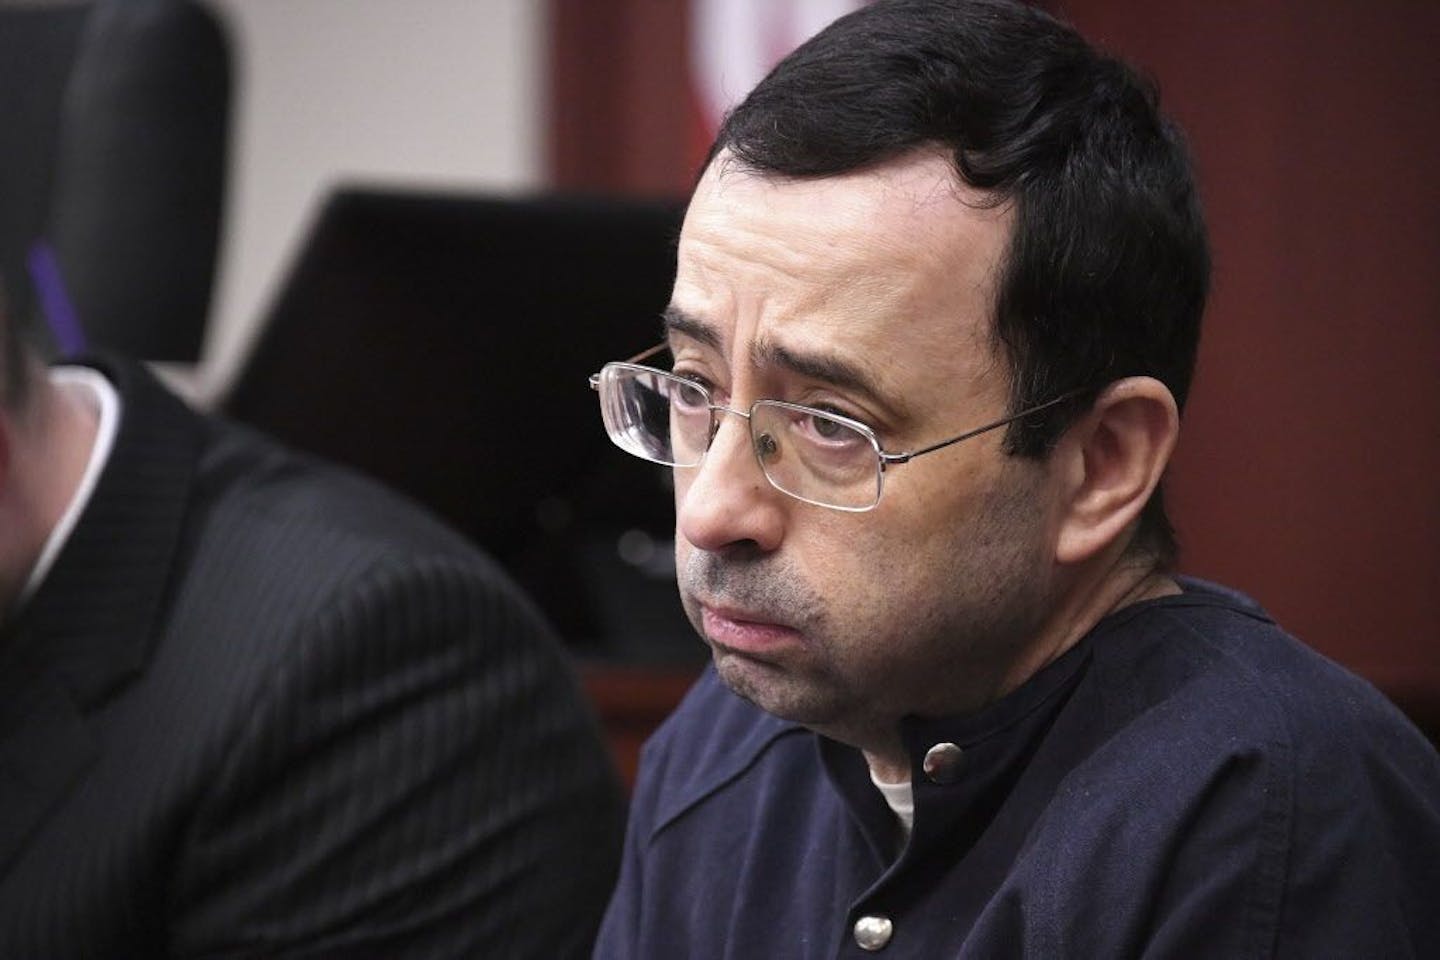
[593,0,1440,960]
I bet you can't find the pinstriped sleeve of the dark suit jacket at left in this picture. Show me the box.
[171,558,622,960]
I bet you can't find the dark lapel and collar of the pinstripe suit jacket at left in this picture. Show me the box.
[0,360,203,874]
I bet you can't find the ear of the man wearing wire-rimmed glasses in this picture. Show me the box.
[1054,377,1179,564]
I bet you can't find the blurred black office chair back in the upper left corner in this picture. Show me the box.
[0,0,230,360]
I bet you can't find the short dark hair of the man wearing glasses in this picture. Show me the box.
[708,0,1210,566]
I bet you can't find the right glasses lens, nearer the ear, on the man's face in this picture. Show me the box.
[750,400,880,510]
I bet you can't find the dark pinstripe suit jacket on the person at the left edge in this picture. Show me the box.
[0,356,622,960]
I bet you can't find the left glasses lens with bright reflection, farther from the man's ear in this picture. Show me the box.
[600,363,710,466]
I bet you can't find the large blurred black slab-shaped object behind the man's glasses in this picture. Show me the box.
[223,189,704,662]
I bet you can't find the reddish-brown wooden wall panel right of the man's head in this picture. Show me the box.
[1064,0,1440,697]
